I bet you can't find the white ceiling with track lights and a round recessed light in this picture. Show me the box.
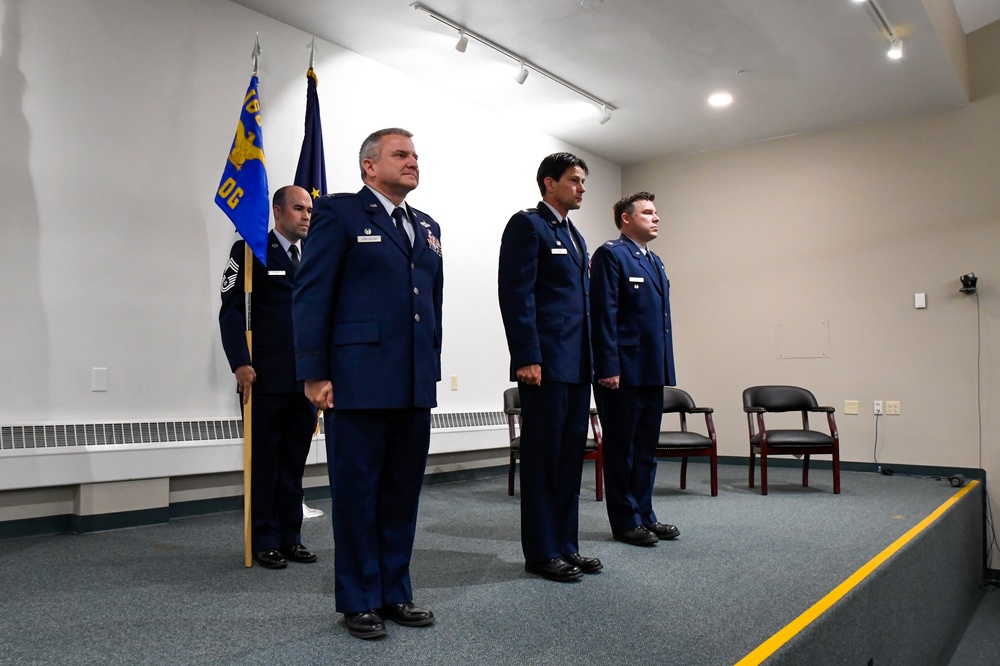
[234,0,1000,165]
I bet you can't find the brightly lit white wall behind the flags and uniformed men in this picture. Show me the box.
[0,0,620,436]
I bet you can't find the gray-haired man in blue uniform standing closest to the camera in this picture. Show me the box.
[294,128,444,638]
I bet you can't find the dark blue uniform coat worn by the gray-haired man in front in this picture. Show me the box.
[295,187,444,409]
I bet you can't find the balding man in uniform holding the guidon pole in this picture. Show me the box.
[219,185,316,569]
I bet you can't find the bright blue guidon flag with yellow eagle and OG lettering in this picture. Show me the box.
[215,76,271,266]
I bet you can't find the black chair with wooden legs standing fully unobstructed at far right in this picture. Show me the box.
[743,386,840,495]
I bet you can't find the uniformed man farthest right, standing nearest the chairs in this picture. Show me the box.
[590,192,679,546]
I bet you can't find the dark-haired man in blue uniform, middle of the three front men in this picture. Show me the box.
[498,153,602,582]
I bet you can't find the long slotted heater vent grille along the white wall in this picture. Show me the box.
[0,412,507,451]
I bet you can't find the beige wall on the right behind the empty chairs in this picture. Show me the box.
[623,23,1000,528]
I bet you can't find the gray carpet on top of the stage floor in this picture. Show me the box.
[0,462,995,666]
